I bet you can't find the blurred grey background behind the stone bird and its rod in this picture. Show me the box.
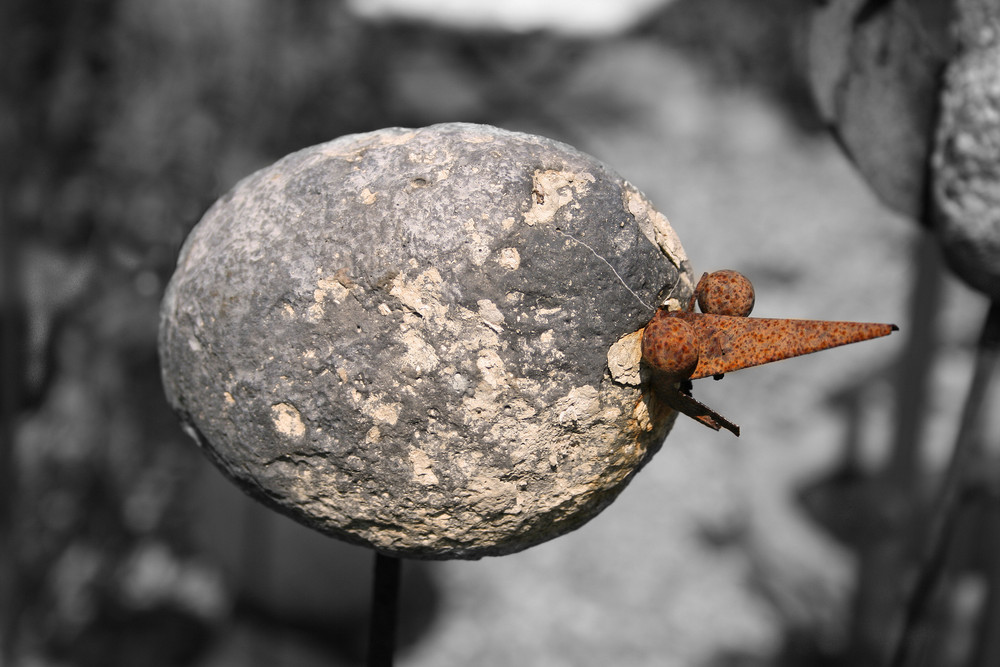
[0,0,987,667]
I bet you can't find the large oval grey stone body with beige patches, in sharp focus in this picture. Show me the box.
[160,124,692,558]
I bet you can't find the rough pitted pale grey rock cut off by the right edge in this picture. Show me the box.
[932,0,1000,299]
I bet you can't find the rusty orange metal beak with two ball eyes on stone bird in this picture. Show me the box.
[642,271,898,436]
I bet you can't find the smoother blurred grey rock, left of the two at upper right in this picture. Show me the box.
[808,0,951,221]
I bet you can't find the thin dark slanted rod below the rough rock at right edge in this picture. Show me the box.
[890,301,1000,667]
